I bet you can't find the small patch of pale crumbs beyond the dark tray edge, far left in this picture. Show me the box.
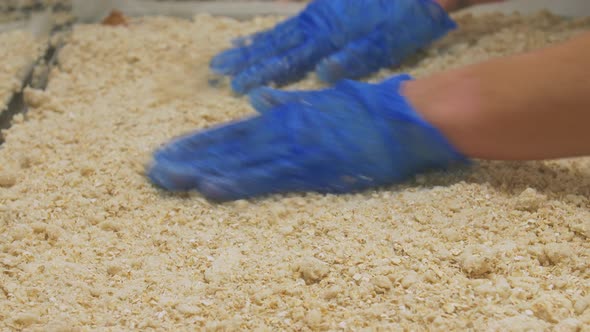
[0,30,45,113]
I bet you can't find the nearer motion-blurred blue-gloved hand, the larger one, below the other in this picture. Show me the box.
[148,75,467,201]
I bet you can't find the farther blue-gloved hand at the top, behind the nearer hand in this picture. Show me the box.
[211,0,456,94]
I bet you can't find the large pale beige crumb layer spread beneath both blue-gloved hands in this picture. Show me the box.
[0,14,590,331]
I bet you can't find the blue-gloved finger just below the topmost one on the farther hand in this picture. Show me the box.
[232,39,334,94]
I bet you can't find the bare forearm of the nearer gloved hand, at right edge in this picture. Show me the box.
[404,33,590,160]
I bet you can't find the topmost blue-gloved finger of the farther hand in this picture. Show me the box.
[210,18,307,75]
